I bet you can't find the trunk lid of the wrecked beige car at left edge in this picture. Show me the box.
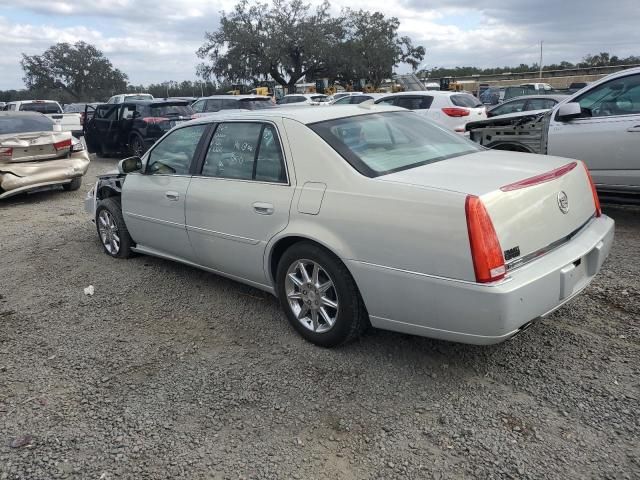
[0,132,72,163]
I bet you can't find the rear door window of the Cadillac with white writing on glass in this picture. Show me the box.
[202,122,286,183]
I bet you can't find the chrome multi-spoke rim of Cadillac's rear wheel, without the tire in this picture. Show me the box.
[285,260,339,333]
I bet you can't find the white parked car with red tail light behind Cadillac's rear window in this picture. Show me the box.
[375,90,487,133]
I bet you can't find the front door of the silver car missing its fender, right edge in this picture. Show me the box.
[548,73,640,188]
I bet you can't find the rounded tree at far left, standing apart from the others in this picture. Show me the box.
[20,42,127,100]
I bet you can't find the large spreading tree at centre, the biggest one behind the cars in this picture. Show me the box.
[197,0,343,91]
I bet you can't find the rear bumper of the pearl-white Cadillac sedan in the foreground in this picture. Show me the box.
[346,215,614,345]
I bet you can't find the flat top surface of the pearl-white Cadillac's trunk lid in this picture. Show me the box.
[377,150,569,196]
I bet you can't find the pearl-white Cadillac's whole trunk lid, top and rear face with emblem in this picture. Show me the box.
[378,151,595,266]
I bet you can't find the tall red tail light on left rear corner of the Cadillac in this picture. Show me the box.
[465,195,507,283]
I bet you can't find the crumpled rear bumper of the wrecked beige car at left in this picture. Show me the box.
[0,151,89,198]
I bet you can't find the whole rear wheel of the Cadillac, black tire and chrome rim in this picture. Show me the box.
[276,242,369,347]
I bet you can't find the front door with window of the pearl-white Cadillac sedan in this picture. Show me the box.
[122,125,208,261]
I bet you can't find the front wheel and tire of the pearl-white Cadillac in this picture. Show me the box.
[96,197,133,258]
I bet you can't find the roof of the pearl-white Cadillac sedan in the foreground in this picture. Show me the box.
[188,103,408,125]
